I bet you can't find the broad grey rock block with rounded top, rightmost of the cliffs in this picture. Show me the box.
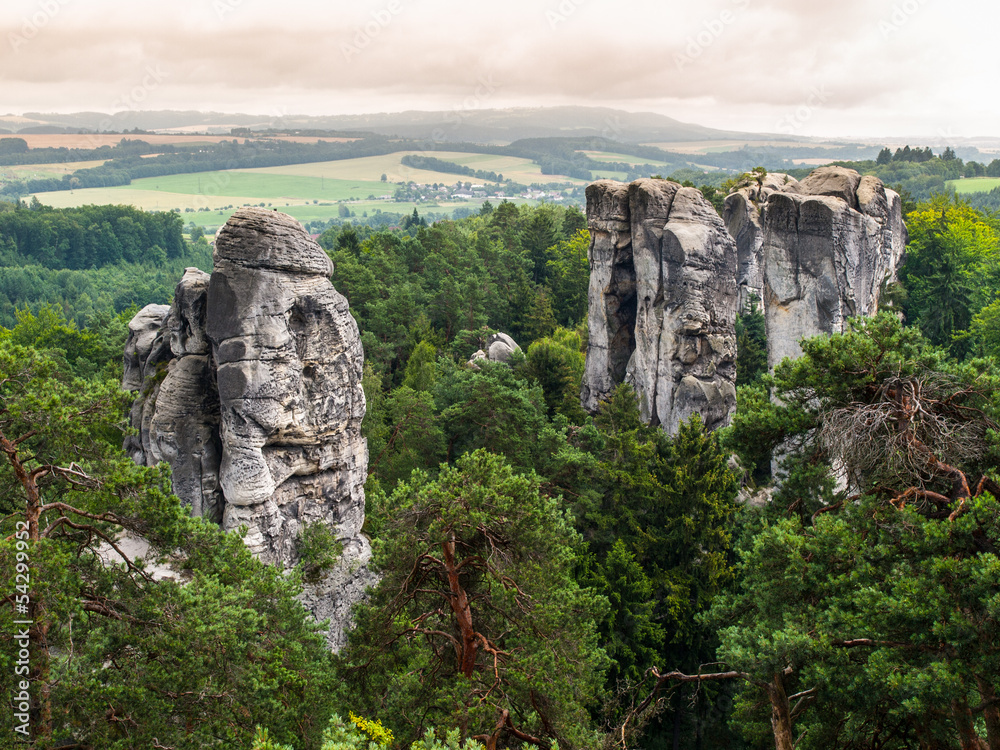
[761,167,907,369]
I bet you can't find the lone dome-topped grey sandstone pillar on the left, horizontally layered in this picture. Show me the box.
[123,208,371,647]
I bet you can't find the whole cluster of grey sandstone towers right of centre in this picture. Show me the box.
[581,167,907,431]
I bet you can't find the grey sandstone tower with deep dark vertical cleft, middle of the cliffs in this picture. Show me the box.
[581,180,737,432]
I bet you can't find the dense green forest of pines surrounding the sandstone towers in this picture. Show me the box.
[0,184,1000,750]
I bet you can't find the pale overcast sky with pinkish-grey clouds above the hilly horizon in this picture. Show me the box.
[0,0,1000,139]
